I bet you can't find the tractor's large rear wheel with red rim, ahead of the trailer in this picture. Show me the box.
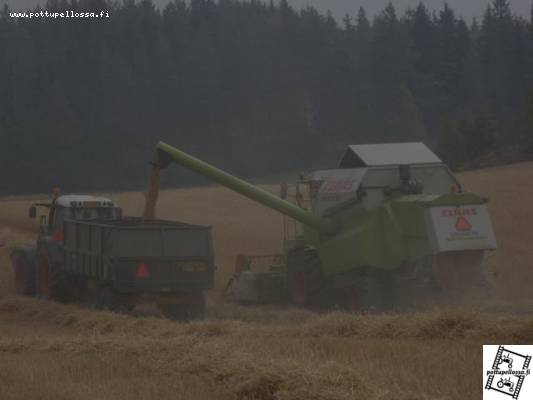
[36,248,69,302]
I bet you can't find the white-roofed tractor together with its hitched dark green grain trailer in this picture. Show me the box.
[11,195,216,319]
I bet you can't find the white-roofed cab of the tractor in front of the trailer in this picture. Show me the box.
[29,191,122,235]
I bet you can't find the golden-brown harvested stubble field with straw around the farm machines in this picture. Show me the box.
[0,163,533,400]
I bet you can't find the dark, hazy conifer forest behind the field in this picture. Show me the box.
[0,0,533,193]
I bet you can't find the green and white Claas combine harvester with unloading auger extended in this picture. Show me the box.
[154,142,496,310]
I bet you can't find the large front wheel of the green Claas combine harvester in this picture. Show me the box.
[287,248,324,307]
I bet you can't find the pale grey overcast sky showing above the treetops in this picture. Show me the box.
[5,0,533,21]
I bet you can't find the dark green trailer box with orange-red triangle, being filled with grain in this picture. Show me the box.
[63,218,215,294]
